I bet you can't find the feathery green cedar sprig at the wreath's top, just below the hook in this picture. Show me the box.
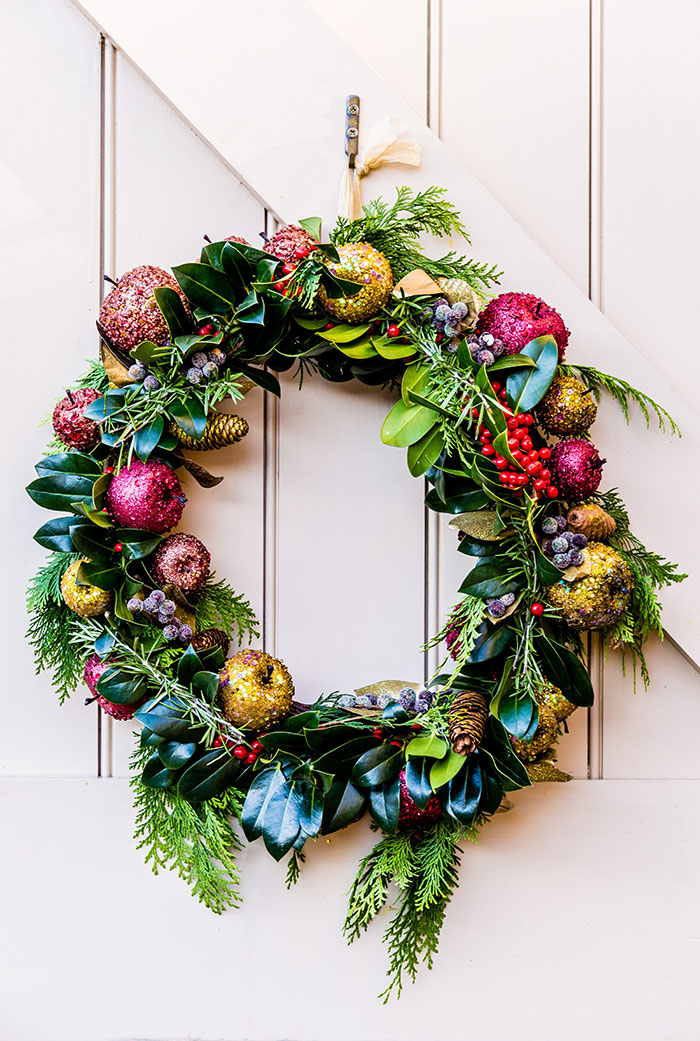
[330,185,501,291]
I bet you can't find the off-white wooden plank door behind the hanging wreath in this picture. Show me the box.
[0,0,700,1041]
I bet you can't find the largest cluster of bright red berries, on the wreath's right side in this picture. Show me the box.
[472,382,559,499]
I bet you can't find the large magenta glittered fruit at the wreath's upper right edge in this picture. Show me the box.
[476,293,569,361]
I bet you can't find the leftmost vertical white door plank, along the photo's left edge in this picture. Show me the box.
[0,0,100,776]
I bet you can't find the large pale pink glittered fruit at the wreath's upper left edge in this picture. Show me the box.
[99,264,191,352]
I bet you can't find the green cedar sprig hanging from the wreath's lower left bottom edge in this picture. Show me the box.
[130,748,243,914]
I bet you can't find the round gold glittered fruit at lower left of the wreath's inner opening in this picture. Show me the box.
[218,650,294,732]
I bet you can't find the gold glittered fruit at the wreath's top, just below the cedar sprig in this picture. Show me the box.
[319,243,394,325]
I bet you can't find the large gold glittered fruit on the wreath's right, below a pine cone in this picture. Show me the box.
[547,542,634,632]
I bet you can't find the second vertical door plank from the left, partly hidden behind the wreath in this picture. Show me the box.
[110,54,265,775]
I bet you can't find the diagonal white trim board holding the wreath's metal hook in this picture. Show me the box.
[76,0,700,662]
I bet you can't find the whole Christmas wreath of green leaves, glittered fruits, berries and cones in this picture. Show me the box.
[27,187,683,999]
